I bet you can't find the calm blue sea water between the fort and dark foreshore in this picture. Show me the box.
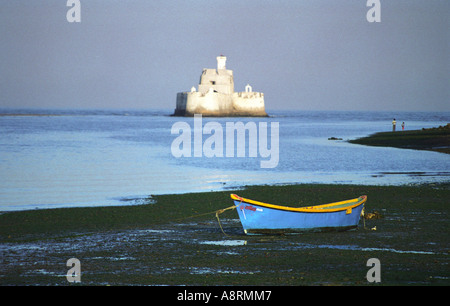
[0,110,450,211]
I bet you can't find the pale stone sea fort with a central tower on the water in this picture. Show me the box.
[174,55,267,117]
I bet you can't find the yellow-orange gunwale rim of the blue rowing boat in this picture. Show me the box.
[231,194,367,213]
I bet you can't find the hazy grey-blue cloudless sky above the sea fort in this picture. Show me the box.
[0,0,450,111]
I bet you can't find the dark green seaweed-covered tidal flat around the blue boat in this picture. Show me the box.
[0,184,450,285]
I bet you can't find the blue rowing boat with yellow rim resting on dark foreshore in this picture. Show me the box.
[231,194,367,234]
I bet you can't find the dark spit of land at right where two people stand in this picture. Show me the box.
[349,123,450,154]
